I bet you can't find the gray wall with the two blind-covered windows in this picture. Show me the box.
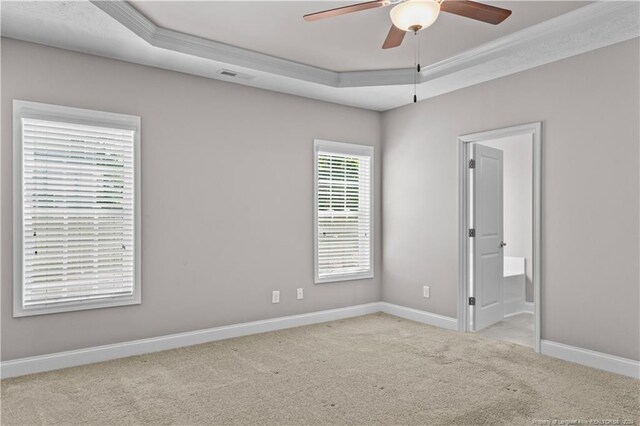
[1,39,381,360]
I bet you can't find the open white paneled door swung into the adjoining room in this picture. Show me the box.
[471,144,504,331]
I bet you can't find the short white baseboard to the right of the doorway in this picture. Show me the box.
[540,340,640,379]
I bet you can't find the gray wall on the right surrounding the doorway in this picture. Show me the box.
[382,39,640,360]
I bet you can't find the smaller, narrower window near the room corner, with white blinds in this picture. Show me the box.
[314,140,373,283]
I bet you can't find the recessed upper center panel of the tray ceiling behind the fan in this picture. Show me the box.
[130,0,590,71]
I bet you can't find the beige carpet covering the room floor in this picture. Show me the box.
[1,314,640,425]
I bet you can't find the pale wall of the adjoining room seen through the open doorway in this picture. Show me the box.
[482,135,533,302]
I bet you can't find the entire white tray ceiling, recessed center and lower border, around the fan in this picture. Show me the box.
[0,0,640,111]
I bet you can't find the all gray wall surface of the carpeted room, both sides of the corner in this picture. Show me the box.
[0,35,640,360]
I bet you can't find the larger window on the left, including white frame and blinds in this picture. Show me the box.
[13,101,140,316]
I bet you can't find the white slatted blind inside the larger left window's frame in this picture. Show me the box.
[21,118,135,309]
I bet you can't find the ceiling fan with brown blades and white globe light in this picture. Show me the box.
[304,0,511,49]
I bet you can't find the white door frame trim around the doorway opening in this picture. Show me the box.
[458,121,542,353]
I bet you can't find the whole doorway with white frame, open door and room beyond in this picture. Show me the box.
[458,122,542,352]
